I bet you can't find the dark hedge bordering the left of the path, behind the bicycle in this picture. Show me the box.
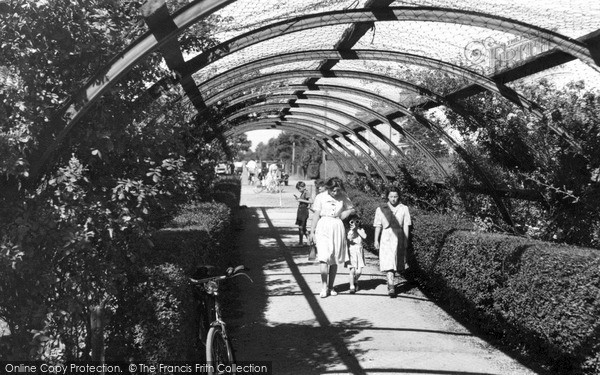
[106,189,239,363]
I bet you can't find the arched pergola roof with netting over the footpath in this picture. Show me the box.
[31,0,600,223]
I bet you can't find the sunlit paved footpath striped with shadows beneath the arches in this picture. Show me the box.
[228,181,535,375]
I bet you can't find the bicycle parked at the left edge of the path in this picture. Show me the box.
[190,265,252,375]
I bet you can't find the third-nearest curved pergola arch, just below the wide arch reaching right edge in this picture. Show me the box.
[199,49,542,117]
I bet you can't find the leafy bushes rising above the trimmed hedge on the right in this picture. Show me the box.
[448,81,600,247]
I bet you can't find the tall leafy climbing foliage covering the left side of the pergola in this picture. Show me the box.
[0,0,230,360]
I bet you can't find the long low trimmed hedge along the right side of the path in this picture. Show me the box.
[351,192,600,375]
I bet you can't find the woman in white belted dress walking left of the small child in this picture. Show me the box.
[310,177,355,298]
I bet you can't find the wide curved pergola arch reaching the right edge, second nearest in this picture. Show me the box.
[182,7,599,74]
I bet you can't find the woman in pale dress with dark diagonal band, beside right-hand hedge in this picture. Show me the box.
[373,187,412,297]
